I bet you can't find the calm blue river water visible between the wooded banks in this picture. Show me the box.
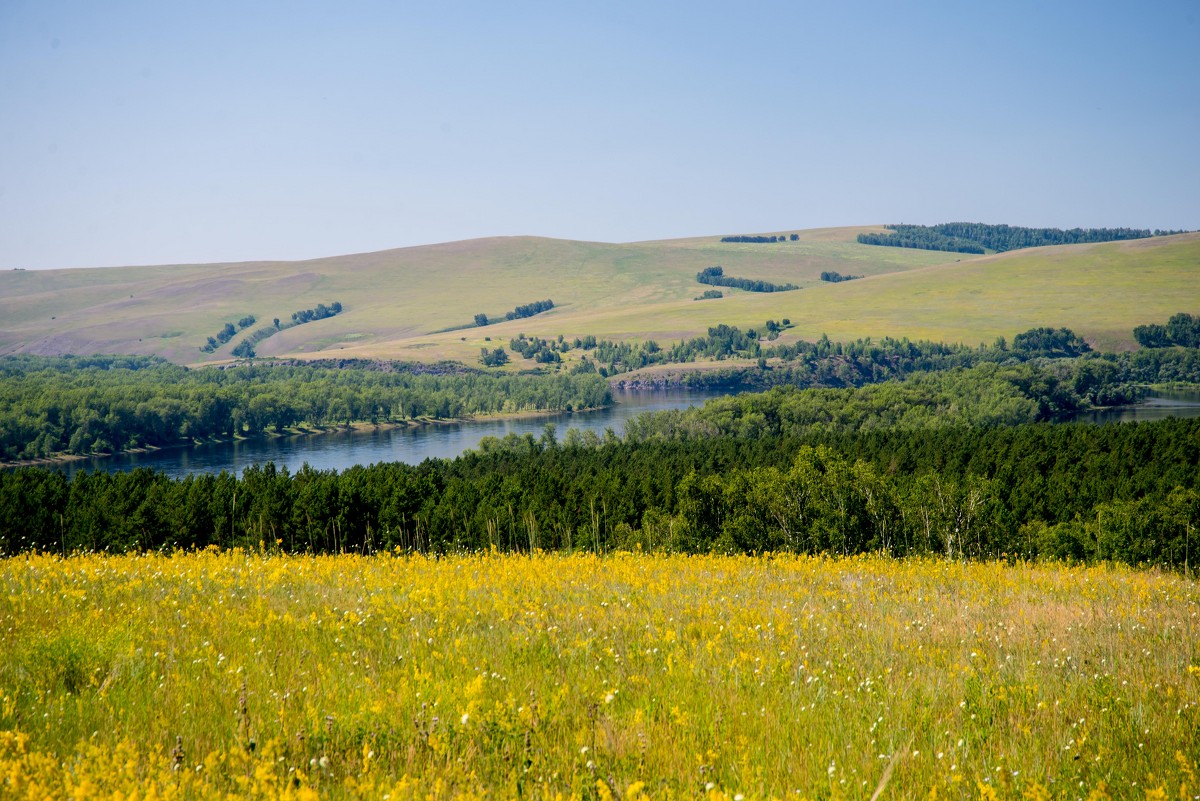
[37,390,1200,477]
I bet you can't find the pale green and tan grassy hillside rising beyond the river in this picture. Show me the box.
[0,228,1200,363]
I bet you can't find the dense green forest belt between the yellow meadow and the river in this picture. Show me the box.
[0,378,1200,567]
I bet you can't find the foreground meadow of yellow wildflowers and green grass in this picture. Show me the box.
[0,552,1200,800]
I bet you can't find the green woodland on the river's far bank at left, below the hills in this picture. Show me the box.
[0,356,611,460]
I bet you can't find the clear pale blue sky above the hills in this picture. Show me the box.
[0,0,1200,269]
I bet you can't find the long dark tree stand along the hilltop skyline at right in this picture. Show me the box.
[858,223,1153,253]
